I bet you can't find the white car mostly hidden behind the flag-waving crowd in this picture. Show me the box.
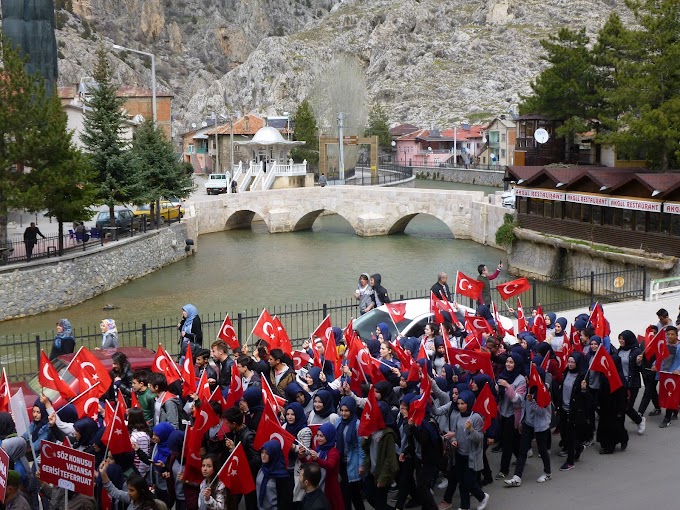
[353,299,517,345]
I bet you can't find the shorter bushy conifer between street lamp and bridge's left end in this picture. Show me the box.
[131,120,193,223]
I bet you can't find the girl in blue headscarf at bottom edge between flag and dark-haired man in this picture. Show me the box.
[255,440,293,510]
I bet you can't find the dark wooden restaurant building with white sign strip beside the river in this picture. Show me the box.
[506,166,680,256]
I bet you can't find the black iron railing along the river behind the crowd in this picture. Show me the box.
[0,268,647,381]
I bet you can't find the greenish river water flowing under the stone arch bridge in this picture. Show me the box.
[0,180,505,337]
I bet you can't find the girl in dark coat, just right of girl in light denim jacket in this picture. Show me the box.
[359,400,399,510]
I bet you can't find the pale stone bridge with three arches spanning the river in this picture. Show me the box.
[194,186,504,244]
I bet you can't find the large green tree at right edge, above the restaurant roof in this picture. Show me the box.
[594,0,680,172]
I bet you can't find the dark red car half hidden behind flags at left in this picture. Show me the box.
[9,347,156,417]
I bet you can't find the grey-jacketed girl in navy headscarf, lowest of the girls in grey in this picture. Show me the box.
[445,388,486,510]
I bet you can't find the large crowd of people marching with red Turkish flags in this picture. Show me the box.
[5,282,680,510]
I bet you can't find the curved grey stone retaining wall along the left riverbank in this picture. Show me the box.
[0,217,198,321]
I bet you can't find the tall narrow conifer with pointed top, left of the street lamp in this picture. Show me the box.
[81,46,145,226]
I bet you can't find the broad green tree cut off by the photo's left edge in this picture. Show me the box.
[0,40,81,263]
